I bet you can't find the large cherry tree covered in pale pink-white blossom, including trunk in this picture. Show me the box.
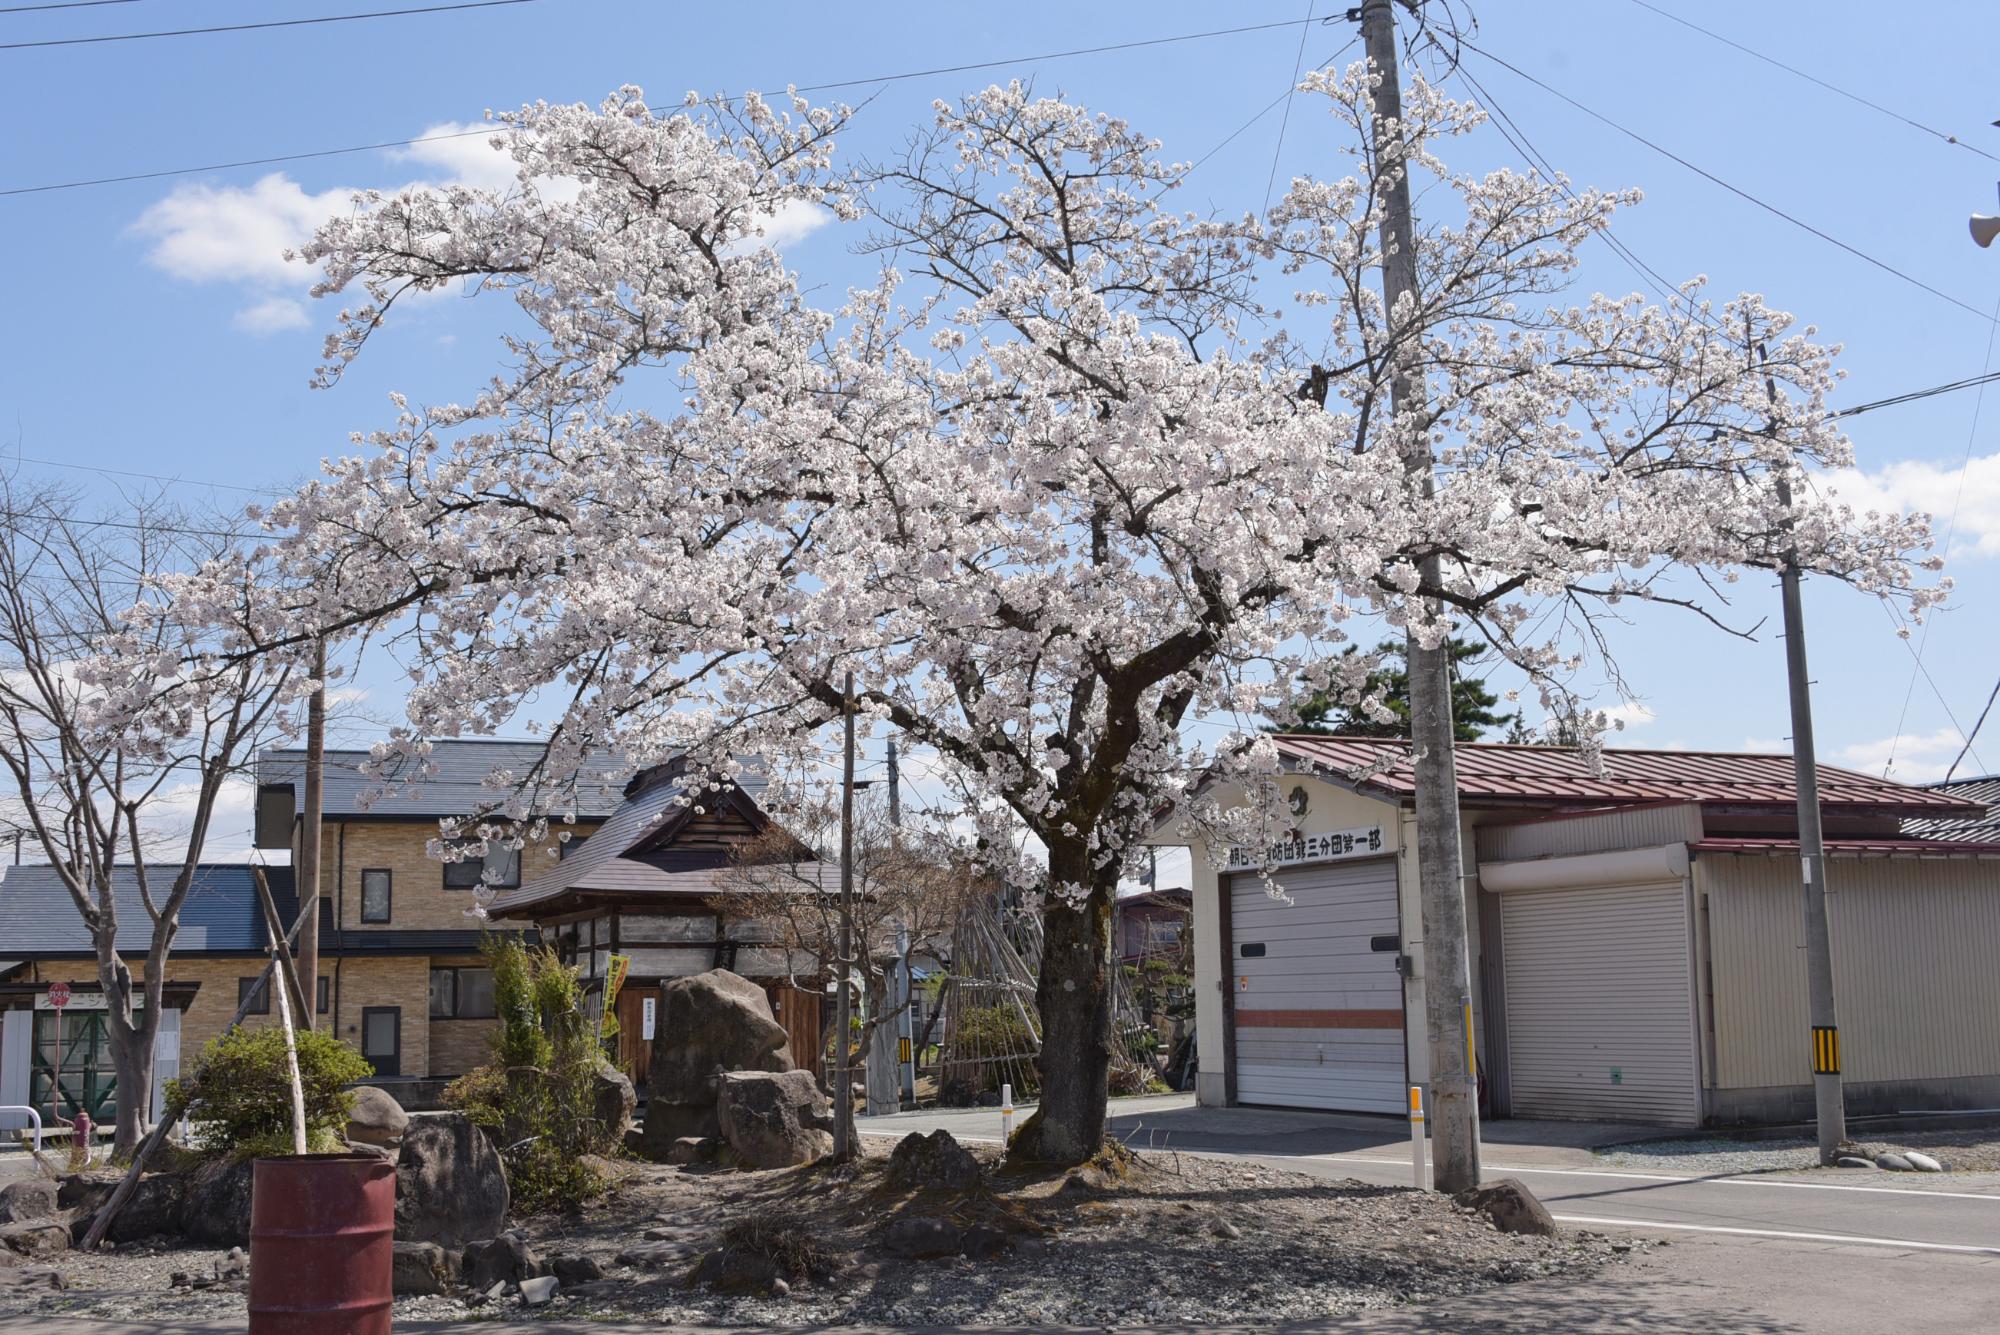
[137,66,1938,1161]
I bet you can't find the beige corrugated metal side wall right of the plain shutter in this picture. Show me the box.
[1694,853,2000,1089]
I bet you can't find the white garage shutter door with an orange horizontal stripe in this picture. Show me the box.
[1226,857,1408,1113]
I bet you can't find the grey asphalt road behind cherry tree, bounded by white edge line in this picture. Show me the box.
[858,1095,2000,1255]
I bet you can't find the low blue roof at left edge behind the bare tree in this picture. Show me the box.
[0,863,298,957]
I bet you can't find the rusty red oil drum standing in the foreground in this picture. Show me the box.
[250,1155,396,1335]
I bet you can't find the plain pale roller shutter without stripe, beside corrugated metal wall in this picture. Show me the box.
[1500,883,1700,1127]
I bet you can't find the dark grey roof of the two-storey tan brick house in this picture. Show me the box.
[256,737,624,819]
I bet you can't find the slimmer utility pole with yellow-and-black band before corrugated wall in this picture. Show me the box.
[1778,474,1848,1165]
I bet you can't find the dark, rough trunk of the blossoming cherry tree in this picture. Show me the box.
[1008,841,1118,1163]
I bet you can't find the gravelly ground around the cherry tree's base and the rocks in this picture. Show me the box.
[0,1141,1650,1327]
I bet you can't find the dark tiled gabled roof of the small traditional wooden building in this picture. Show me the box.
[488,773,840,917]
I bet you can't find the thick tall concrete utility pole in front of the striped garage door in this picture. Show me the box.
[1362,0,1480,1193]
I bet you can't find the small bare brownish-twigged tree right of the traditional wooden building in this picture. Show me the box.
[710,791,994,1087]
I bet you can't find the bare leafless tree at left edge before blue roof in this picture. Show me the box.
[0,484,290,1157]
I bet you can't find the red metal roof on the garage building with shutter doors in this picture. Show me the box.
[1272,733,1984,815]
